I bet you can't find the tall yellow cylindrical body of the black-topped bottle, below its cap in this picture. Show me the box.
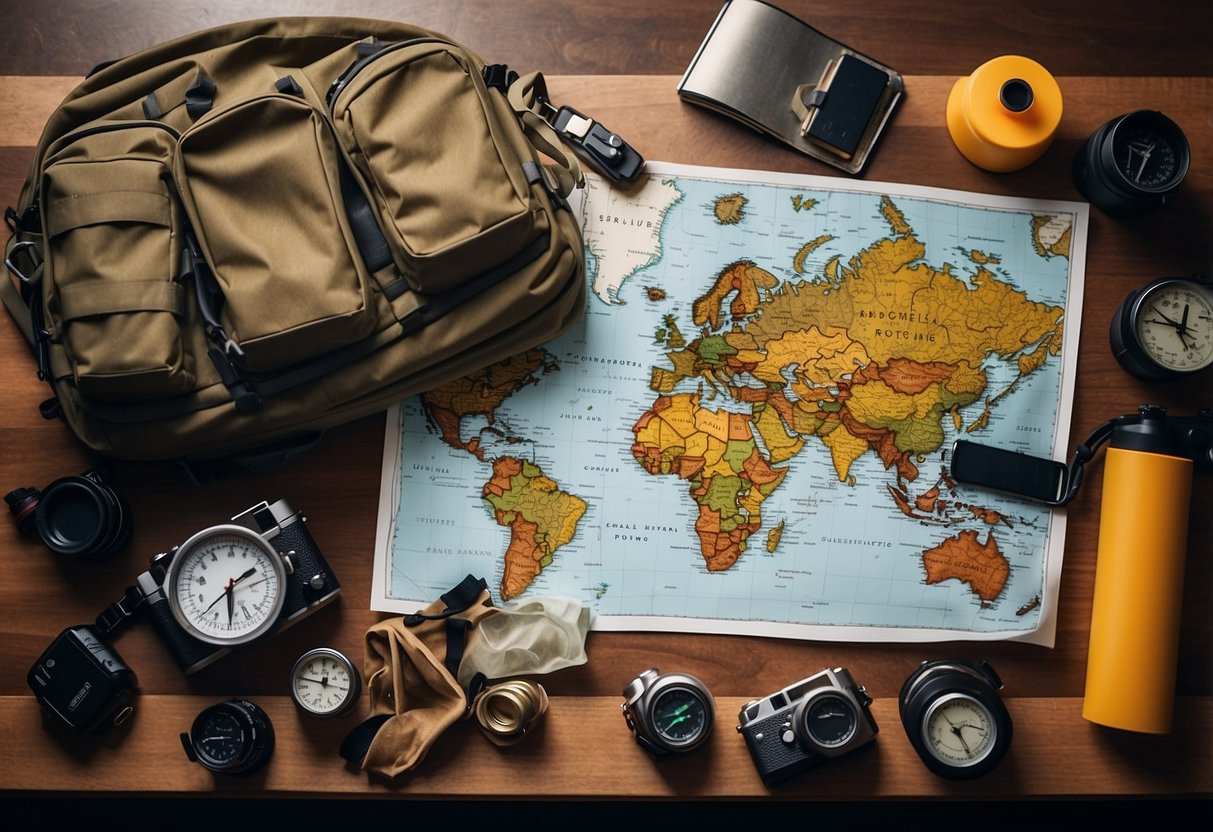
[1082,448,1192,734]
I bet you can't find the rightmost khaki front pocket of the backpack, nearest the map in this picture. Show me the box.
[330,40,546,294]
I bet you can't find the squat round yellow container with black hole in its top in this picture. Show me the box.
[947,55,1061,173]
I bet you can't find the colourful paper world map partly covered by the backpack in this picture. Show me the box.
[376,165,1086,643]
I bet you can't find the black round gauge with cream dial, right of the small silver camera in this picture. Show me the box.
[898,659,1012,780]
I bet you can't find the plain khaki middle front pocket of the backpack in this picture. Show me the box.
[177,95,376,371]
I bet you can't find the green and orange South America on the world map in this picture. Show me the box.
[482,456,586,600]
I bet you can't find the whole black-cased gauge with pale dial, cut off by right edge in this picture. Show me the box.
[1109,278,1213,381]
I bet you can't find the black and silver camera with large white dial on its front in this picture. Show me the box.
[136,500,341,674]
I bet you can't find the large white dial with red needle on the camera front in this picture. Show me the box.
[164,525,286,645]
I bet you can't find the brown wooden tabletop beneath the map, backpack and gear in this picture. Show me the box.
[0,2,1213,815]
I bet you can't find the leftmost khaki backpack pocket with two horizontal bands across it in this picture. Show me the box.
[41,122,194,401]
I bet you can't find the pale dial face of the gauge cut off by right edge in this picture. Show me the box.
[1133,280,1213,372]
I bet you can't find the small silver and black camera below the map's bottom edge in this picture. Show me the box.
[738,667,879,786]
